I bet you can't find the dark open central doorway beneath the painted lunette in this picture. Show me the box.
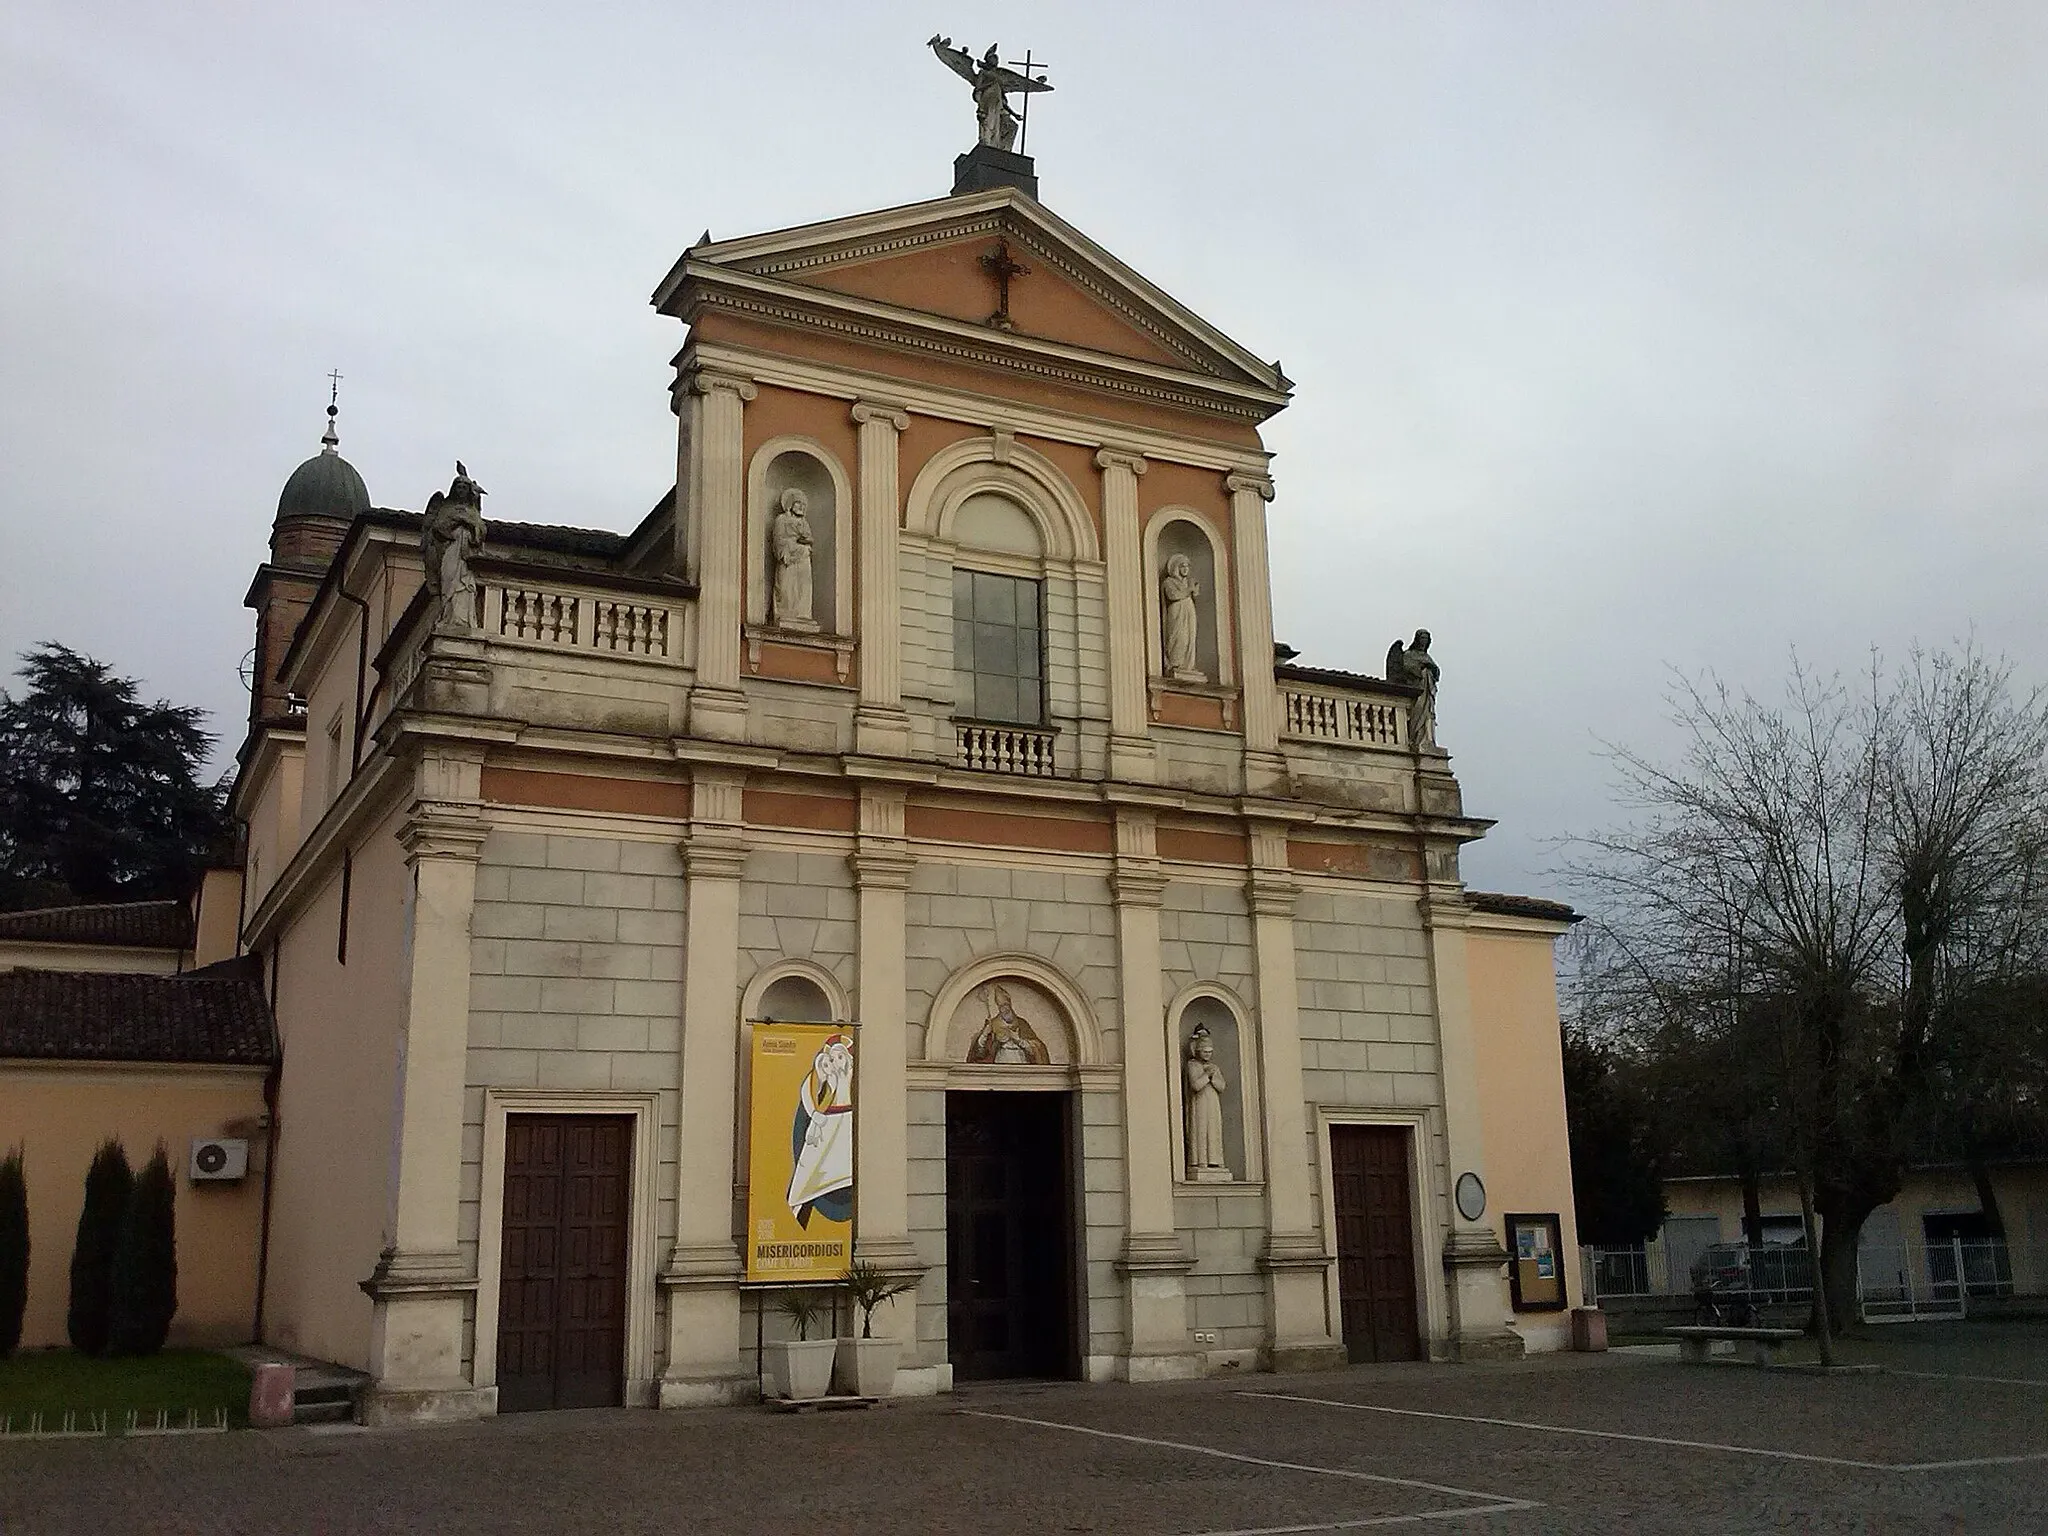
[946,1094,1077,1380]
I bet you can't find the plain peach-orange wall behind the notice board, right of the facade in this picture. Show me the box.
[1466,926,1585,1350]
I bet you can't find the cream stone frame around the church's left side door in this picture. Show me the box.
[471,1087,662,1413]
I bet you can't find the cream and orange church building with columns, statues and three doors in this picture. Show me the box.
[236,153,1577,1421]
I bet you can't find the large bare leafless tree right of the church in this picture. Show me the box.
[1573,647,2048,1339]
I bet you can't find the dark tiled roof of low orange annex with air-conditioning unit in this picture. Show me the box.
[0,961,276,1067]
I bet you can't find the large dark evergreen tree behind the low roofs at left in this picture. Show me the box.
[0,643,231,911]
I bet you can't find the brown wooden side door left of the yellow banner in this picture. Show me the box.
[498,1114,633,1413]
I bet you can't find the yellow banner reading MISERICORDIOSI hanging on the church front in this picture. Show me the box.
[748,1024,854,1284]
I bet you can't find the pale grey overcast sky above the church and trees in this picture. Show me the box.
[0,0,2048,893]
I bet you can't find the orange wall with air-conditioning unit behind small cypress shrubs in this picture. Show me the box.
[0,1061,262,1350]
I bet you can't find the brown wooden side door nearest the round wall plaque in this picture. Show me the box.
[1329,1124,1421,1362]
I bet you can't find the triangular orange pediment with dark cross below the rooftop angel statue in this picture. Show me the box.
[655,186,1286,410]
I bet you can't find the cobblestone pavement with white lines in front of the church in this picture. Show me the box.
[0,1325,2048,1536]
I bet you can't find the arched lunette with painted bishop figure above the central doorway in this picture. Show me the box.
[924,954,1102,1067]
